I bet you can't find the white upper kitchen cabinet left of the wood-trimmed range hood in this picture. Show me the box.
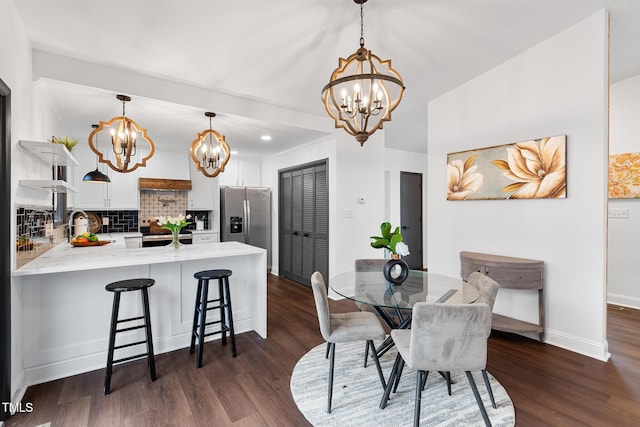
[75,149,138,210]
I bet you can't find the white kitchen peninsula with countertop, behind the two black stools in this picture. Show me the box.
[13,234,267,385]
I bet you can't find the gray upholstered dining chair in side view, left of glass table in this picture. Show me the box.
[311,271,386,413]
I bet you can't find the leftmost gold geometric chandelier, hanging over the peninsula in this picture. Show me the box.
[89,95,155,173]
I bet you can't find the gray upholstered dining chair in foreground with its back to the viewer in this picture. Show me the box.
[380,302,491,426]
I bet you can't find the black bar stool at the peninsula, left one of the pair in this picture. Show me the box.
[104,279,156,395]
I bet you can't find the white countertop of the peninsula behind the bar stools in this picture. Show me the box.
[13,233,266,276]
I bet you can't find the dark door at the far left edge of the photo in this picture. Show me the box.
[0,80,13,421]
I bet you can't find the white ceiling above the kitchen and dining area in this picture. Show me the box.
[14,0,640,157]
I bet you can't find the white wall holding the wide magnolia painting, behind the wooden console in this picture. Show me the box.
[427,11,608,360]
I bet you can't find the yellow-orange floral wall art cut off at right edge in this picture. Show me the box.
[609,153,640,199]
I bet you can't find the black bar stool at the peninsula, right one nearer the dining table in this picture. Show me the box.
[189,270,237,368]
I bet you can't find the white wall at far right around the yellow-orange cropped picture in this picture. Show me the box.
[607,75,640,309]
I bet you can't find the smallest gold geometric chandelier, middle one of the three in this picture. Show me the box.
[189,111,231,178]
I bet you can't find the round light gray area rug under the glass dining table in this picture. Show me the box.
[291,342,515,427]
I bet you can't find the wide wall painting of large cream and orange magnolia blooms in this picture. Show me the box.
[447,135,567,200]
